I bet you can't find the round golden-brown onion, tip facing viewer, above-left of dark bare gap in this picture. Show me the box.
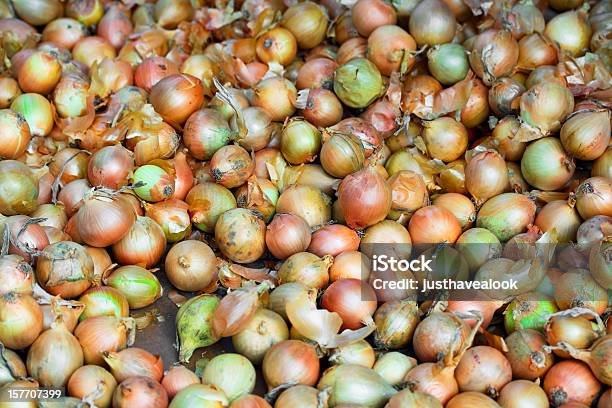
[164,240,216,292]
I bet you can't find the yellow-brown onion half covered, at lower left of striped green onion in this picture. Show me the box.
[79,286,130,320]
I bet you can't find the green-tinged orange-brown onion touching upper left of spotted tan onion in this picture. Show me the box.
[185,182,237,233]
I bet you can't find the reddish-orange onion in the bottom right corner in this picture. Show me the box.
[543,360,601,406]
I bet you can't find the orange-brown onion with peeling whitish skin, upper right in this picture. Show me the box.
[469,29,519,86]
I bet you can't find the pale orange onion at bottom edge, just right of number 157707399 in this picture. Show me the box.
[66,365,117,407]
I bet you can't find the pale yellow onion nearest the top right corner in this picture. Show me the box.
[544,10,592,57]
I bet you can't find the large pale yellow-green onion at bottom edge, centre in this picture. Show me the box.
[317,364,397,407]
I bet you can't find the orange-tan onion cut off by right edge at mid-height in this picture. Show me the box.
[576,177,612,220]
